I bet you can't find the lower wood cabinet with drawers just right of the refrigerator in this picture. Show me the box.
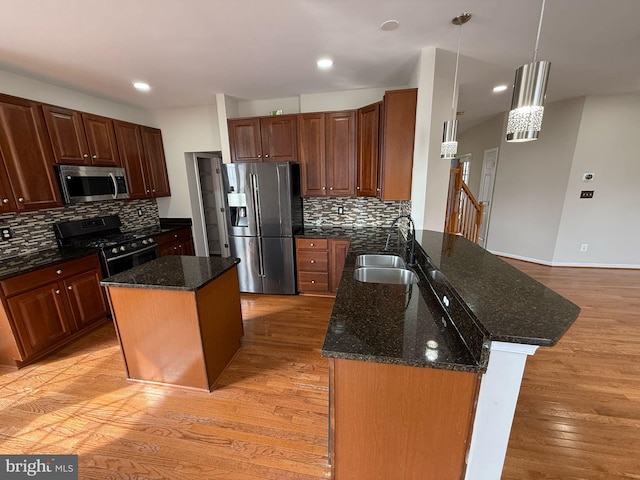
[296,238,349,295]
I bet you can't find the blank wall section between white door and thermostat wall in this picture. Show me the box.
[487,97,584,263]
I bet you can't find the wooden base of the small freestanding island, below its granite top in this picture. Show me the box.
[108,267,243,391]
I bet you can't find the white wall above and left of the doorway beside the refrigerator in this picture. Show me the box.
[152,103,220,223]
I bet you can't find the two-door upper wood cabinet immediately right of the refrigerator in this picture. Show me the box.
[298,111,356,197]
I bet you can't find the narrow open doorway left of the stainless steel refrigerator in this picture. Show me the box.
[194,152,231,257]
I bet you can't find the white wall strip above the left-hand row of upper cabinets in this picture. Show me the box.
[0,70,152,127]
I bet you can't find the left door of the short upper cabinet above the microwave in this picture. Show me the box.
[42,105,91,165]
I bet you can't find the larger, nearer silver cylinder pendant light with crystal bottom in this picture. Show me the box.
[507,0,551,142]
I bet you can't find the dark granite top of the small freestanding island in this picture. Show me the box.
[100,255,239,291]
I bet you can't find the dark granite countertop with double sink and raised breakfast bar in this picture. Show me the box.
[308,226,580,371]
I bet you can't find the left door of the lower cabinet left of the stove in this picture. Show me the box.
[7,283,71,356]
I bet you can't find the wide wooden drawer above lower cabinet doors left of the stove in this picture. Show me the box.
[0,255,100,297]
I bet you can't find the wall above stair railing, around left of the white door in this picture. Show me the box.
[458,113,506,198]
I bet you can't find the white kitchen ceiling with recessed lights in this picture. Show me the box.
[0,0,640,129]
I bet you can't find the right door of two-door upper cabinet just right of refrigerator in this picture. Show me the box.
[325,111,356,196]
